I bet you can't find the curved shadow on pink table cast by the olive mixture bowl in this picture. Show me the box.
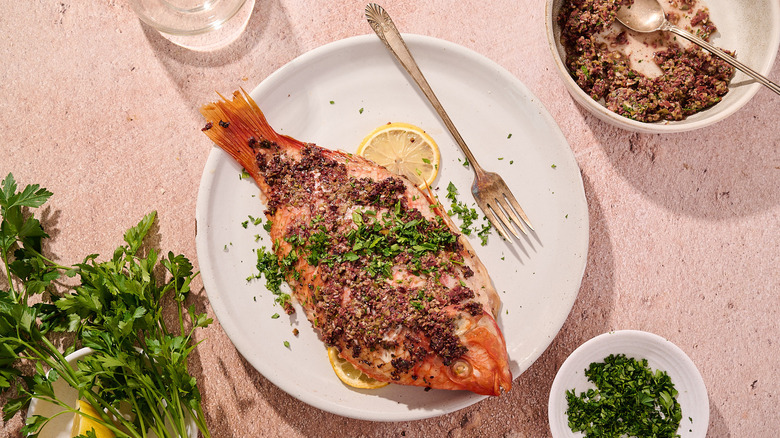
[576,93,780,220]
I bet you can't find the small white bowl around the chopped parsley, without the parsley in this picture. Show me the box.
[547,330,710,438]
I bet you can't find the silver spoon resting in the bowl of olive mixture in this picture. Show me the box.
[617,0,780,94]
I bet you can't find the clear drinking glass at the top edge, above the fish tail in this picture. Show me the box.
[130,0,255,50]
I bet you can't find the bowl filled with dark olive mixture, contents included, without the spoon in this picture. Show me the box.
[546,0,780,133]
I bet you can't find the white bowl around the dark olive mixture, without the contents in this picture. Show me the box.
[545,0,780,133]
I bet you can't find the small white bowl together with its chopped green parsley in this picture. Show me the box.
[548,330,709,438]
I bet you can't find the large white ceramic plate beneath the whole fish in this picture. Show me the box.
[196,35,588,421]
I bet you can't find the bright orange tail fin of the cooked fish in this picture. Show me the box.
[200,89,303,181]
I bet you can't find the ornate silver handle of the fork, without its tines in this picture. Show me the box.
[366,3,483,175]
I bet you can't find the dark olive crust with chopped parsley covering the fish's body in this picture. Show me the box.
[253,145,483,379]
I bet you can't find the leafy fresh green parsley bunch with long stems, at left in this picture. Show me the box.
[0,174,211,438]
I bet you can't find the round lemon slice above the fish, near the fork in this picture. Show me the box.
[357,123,440,189]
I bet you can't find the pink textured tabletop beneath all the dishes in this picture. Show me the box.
[0,0,780,438]
